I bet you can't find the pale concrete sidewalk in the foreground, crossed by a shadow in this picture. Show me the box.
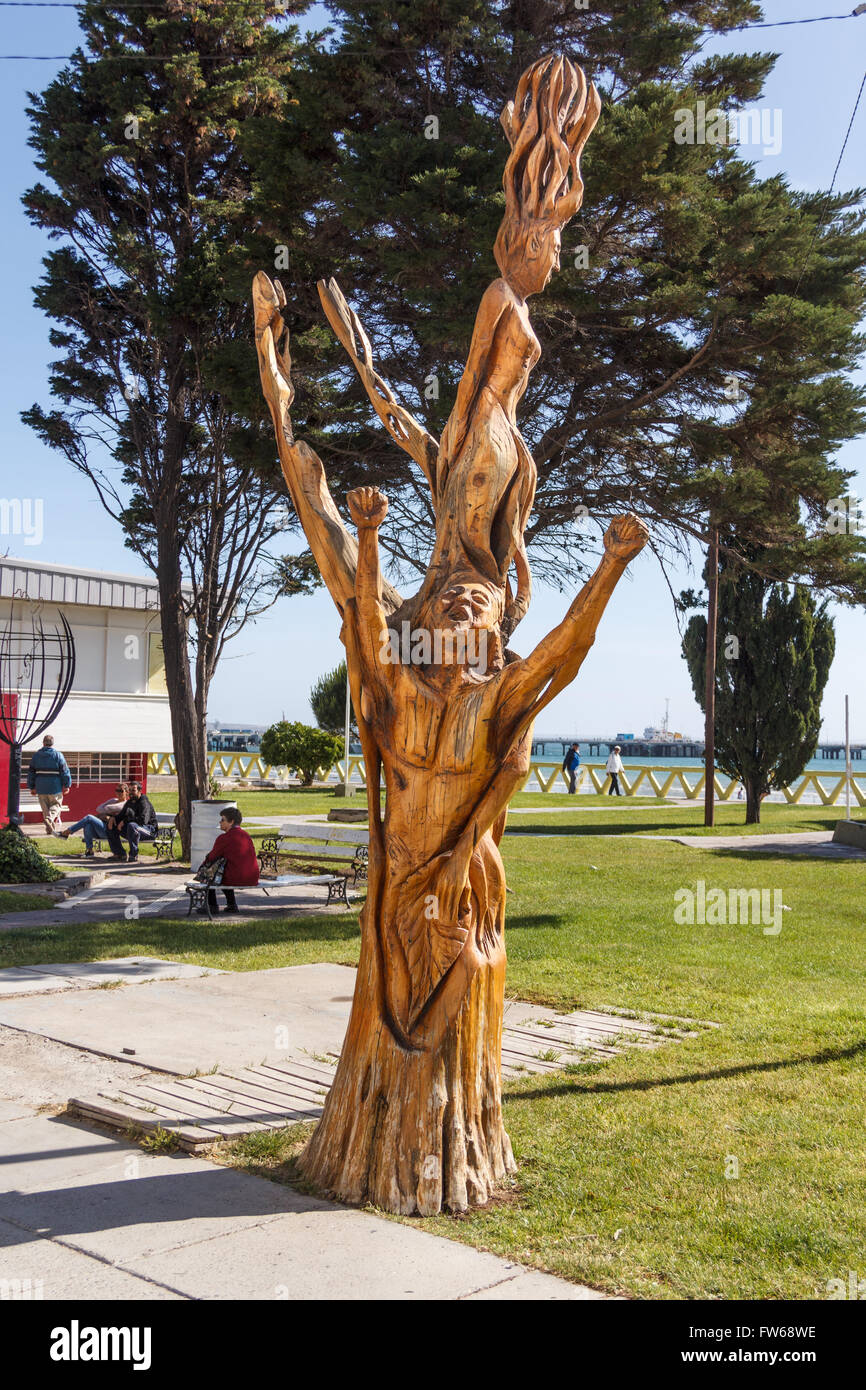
[0,1101,606,1301]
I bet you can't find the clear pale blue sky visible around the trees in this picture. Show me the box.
[0,0,866,742]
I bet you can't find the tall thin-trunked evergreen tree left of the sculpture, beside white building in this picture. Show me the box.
[24,0,315,848]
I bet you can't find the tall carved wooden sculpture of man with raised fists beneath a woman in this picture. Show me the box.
[253,57,646,1215]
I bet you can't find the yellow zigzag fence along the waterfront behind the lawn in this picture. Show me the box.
[147,753,866,806]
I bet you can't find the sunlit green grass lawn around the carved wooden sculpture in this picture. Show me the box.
[0,811,866,1298]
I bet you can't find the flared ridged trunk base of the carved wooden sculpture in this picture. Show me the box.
[300,872,516,1216]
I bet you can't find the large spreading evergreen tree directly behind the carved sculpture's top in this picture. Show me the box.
[257,0,866,596]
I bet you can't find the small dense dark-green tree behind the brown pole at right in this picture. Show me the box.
[683,555,835,826]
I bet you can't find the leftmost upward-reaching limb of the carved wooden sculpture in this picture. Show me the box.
[253,271,402,614]
